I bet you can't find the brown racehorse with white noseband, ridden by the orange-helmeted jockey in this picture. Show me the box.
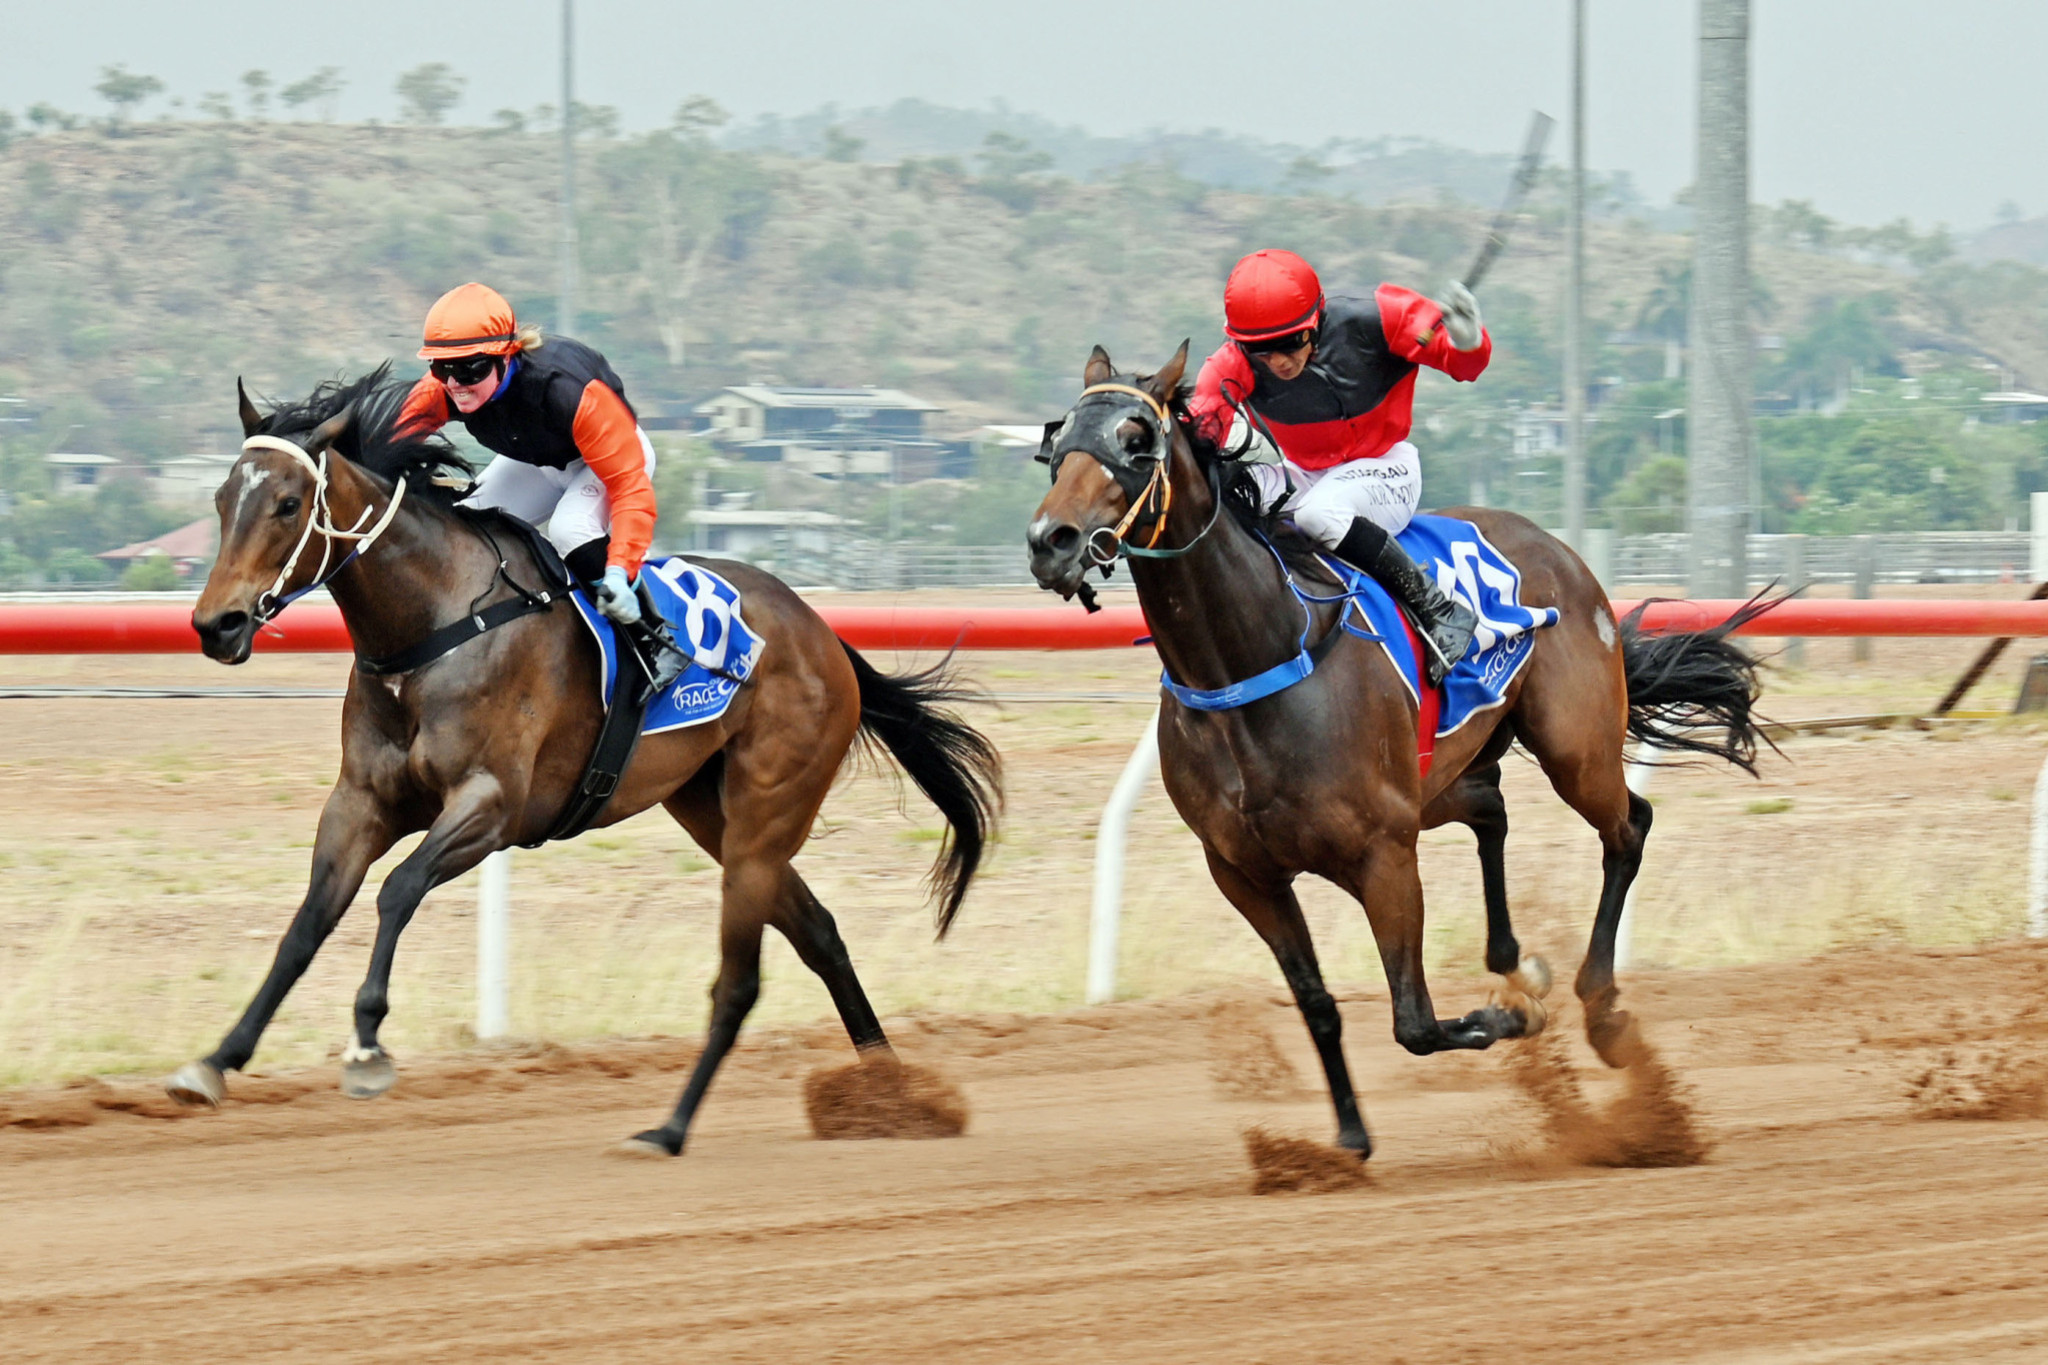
[168,370,1001,1156]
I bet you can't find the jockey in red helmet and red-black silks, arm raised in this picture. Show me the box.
[1190,250,1493,686]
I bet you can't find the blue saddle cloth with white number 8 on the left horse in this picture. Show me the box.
[575,557,764,735]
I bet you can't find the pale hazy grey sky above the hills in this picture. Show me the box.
[0,0,2048,231]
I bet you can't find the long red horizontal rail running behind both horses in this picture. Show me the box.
[0,600,2048,655]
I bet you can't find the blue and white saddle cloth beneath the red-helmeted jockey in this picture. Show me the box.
[1323,516,1559,735]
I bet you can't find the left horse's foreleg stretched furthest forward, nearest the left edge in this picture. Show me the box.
[164,786,397,1105]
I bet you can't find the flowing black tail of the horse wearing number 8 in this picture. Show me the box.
[842,641,1004,937]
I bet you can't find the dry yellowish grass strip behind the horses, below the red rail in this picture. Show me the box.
[0,589,2040,1085]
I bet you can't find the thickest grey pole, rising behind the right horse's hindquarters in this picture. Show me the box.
[1686,0,1755,598]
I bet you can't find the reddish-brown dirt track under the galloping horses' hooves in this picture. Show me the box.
[0,945,2048,1363]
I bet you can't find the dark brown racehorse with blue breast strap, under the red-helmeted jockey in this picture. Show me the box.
[1028,344,1763,1156]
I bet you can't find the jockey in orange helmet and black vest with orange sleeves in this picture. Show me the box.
[393,284,680,688]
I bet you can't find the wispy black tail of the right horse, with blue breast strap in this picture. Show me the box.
[1622,589,1792,776]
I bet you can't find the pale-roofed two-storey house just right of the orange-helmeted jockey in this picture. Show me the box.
[696,385,973,481]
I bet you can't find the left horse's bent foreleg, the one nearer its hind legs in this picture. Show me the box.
[342,774,506,1099]
